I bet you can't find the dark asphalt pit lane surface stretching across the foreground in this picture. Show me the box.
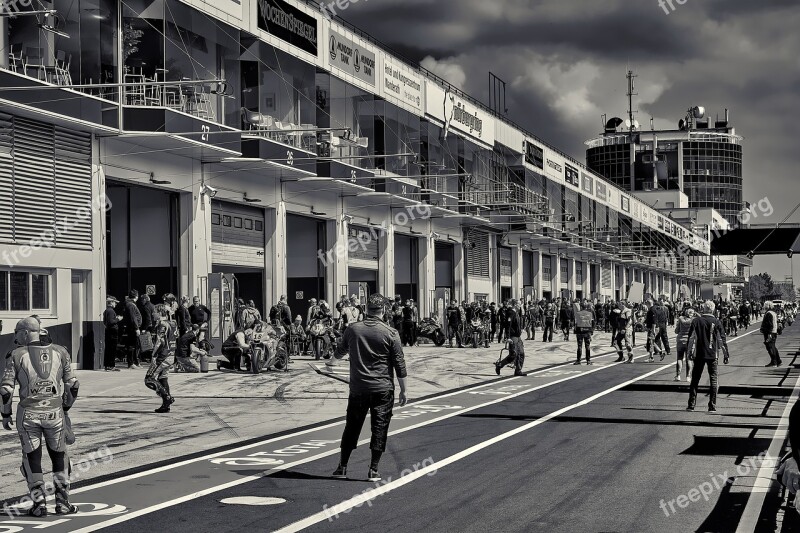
[3,326,800,531]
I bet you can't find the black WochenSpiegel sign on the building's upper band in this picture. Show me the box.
[258,0,318,56]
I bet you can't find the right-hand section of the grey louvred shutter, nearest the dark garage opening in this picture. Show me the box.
[55,128,92,248]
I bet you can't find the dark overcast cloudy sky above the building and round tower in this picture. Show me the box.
[340,0,800,281]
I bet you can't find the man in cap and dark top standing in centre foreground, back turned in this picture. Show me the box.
[326,293,407,481]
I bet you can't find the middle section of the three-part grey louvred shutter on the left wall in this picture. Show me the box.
[14,117,55,242]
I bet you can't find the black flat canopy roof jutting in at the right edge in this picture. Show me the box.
[711,226,800,255]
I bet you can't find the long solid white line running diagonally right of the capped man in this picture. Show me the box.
[276,364,673,533]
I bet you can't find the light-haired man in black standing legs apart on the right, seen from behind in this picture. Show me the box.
[686,300,730,413]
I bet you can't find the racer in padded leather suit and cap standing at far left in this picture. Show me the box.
[0,318,78,517]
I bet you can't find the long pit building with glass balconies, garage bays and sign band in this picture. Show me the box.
[0,0,710,369]
